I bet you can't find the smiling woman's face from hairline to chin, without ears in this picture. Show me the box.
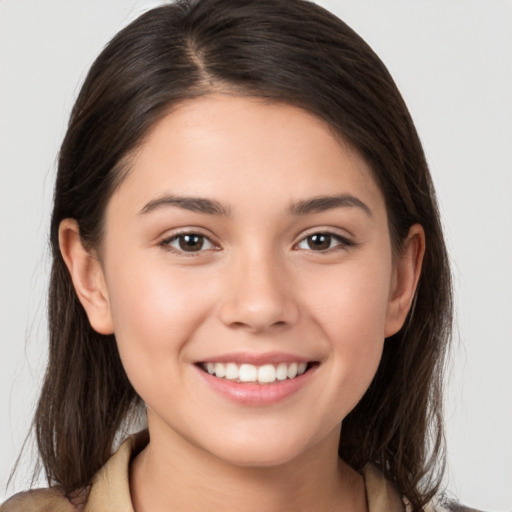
[85,95,412,466]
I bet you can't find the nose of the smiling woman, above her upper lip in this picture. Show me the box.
[219,251,299,333]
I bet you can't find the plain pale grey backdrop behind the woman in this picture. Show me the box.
[0,0,512,511]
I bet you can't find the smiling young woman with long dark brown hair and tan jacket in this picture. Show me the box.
[1,0,472,512]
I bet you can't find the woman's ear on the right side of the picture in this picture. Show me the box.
[384,224,425,338]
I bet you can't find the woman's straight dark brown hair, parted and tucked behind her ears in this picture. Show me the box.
[35,0,452,510]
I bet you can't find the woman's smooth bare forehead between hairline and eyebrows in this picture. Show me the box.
[112,94,384,216]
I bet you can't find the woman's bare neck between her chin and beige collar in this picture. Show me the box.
[130,420,367,512]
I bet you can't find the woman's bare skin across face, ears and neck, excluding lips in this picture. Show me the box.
[60,94,424,512]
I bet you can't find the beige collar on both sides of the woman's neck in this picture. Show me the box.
[84,432,405,512]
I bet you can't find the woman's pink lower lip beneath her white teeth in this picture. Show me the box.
[196,366,317,405]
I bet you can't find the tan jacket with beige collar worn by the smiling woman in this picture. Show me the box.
[0,435,476,512]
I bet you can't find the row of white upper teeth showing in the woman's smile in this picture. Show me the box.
[203,363,307,384]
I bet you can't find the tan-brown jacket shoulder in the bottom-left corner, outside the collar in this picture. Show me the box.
[0,487,89,512]
